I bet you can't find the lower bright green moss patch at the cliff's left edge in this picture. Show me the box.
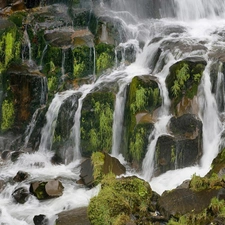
[1,100,15,131]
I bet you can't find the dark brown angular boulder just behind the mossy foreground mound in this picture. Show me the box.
[80,152,126,186]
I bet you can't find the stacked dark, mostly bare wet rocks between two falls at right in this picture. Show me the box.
[154,114,202,176]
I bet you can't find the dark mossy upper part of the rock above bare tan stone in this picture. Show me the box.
[166,58,206,113]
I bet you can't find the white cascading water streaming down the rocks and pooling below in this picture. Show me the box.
[0,0,225,225]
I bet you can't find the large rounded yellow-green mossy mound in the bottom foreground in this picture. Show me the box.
[88,175,152,225]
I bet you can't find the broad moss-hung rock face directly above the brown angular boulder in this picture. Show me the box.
[81,91,115,157]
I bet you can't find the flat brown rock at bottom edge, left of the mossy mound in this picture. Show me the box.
[56,207,91,225]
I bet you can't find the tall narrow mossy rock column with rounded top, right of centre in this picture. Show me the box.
[122,76,161,162]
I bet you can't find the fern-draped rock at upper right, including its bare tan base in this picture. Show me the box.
[166,57,206,116]
